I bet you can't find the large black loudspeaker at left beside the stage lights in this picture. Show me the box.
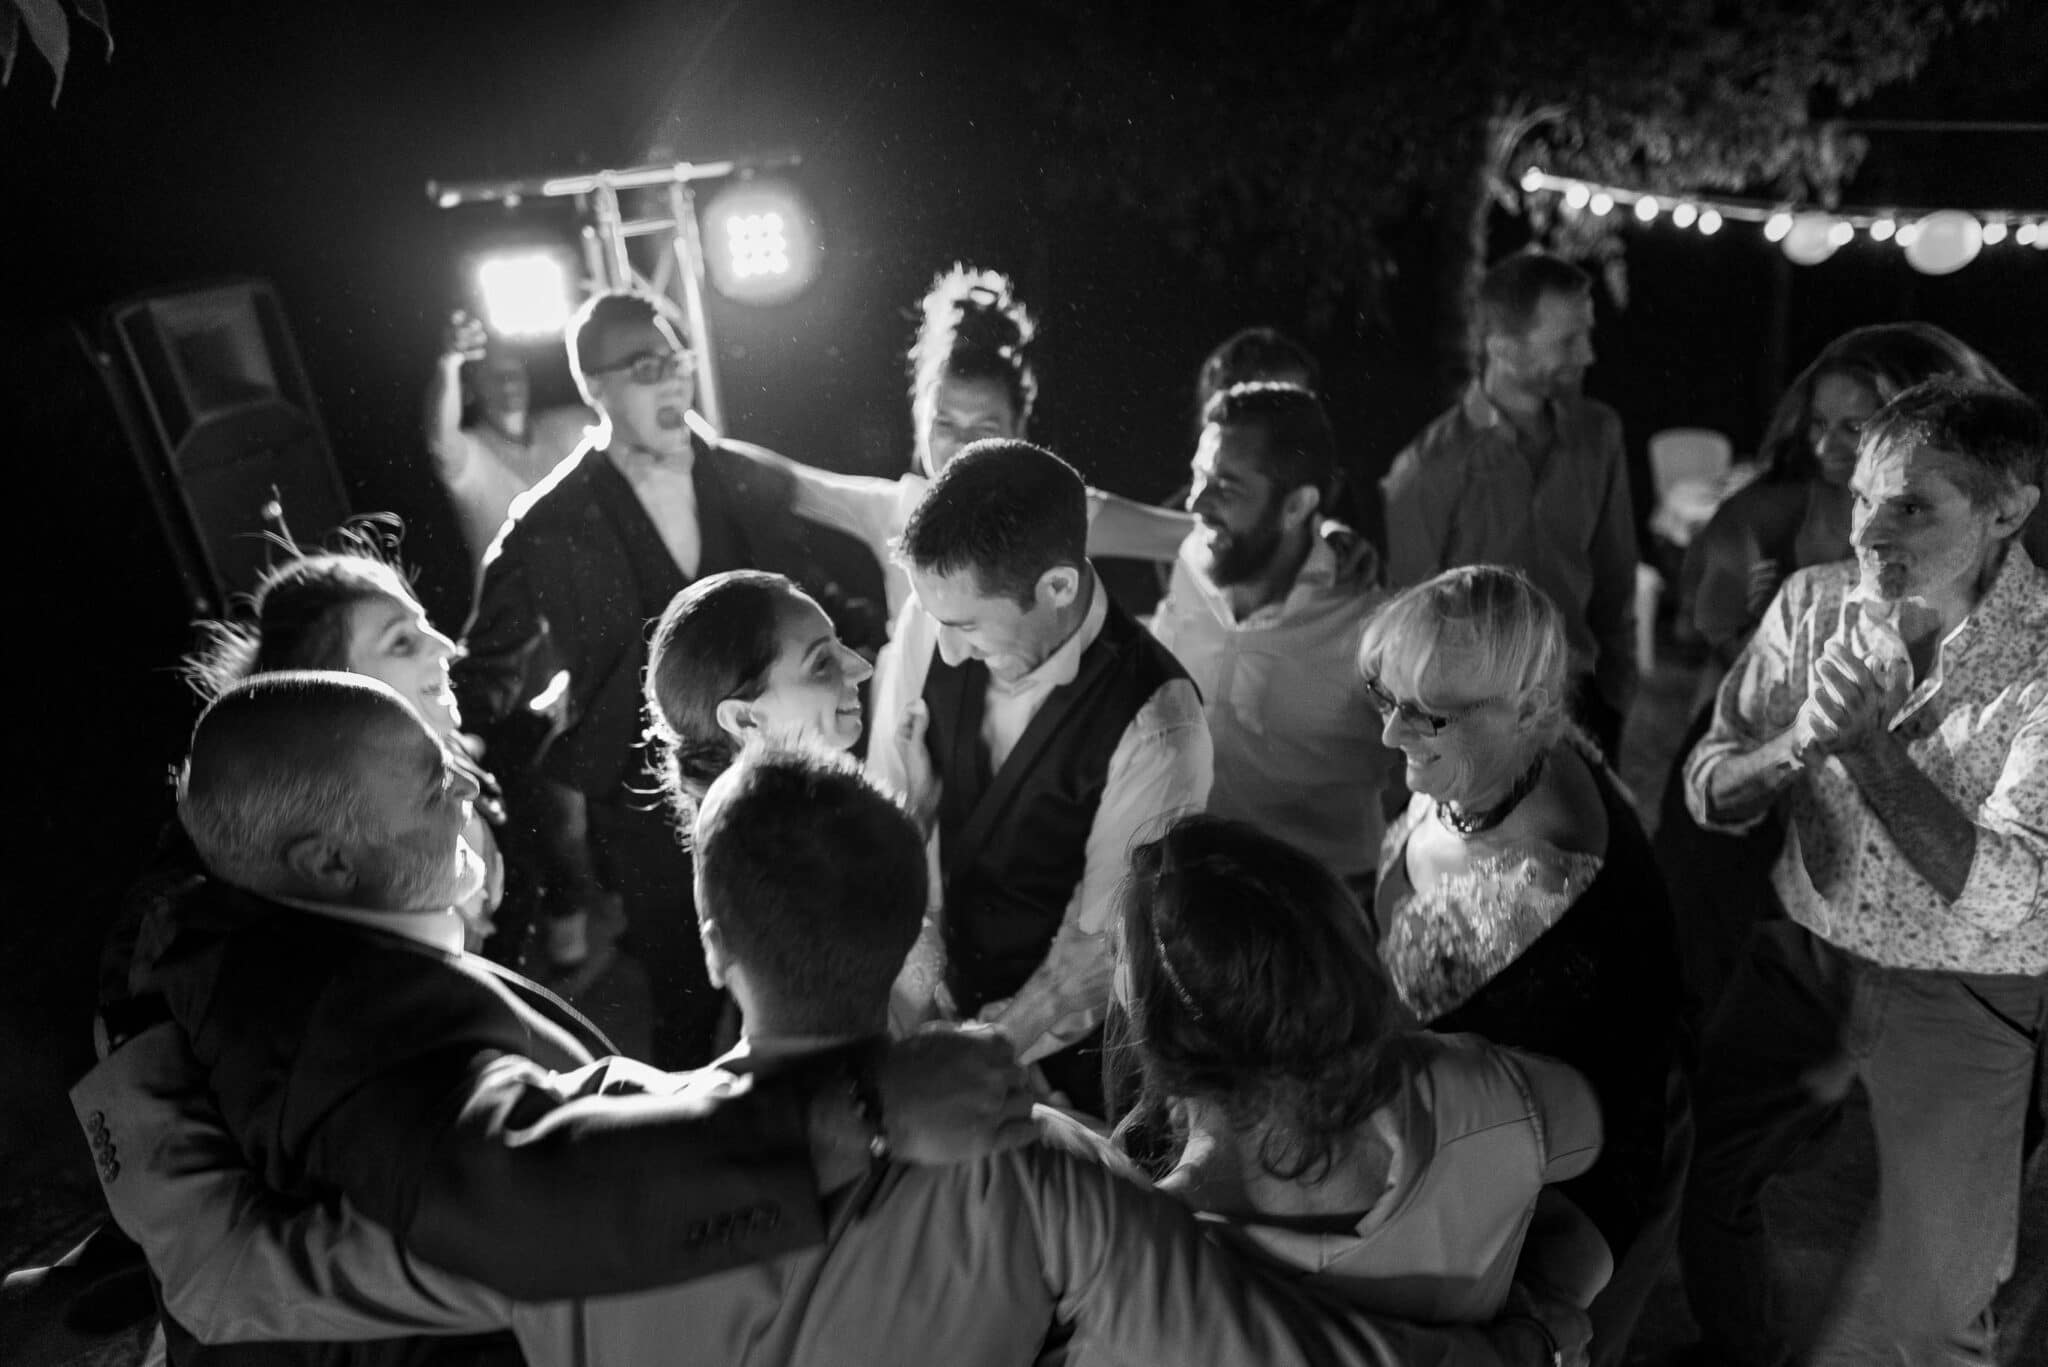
[98,281,348,613]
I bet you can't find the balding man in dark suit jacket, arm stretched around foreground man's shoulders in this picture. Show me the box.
[144,674,1028,1363]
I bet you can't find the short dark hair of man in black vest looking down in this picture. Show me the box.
[899,439,1087,609]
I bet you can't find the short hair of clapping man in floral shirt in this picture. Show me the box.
[1860,377,2048,508]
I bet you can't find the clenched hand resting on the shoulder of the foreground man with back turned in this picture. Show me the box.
[874,1029,1038,1164]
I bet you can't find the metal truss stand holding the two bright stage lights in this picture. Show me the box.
[426,156,799,430]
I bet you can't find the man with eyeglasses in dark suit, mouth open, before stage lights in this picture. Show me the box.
[455,293,819,1066]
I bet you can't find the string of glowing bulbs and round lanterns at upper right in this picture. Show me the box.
[1520,166,2048,275]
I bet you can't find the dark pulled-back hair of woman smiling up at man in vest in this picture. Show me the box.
[645,570,803,823]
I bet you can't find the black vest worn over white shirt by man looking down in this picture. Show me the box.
[924,598,1188,1014]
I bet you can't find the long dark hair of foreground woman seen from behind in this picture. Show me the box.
[1120,816,1407,1180]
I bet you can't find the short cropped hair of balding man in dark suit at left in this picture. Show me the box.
[178,670,401,892]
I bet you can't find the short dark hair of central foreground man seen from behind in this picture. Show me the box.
[696,740,926,1029]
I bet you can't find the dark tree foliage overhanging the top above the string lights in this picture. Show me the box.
[1032,0,1999,393]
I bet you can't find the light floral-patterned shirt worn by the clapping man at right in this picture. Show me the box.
[1686,543,2048,976]
